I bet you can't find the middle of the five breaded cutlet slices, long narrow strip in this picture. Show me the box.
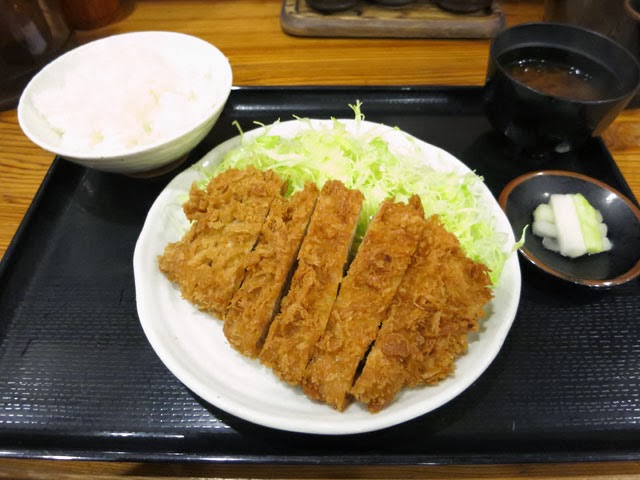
[259,180,363,385]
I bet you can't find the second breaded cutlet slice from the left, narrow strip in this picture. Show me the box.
[223,183,319,358]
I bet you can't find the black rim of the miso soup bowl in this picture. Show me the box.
[489,22,640,105]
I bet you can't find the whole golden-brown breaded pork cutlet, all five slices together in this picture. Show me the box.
[158,167,492,412]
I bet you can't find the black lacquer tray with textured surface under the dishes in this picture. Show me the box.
[0,87,640,465]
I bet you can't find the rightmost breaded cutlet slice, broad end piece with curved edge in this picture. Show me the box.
[351,216,492,412]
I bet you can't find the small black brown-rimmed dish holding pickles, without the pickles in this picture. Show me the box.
[498,170,640,289]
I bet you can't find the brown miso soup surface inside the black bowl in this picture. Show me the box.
[499,47,622,100]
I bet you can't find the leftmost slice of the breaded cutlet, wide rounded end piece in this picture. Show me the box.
[158,168,286,319]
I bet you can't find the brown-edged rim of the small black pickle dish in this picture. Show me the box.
[498,170,640,289]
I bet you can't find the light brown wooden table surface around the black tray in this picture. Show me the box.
[0,0,640,479]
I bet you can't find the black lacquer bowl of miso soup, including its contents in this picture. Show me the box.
[484,23,640,155]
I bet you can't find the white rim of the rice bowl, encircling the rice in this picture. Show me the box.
[17,30,233,163]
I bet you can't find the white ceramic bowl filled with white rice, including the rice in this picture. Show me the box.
[18,32,232,174]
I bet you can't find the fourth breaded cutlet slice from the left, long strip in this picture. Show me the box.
[302,195,424,411]
